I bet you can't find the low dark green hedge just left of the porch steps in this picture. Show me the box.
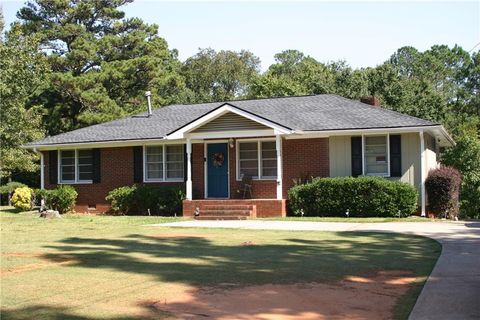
[105,185,185,216]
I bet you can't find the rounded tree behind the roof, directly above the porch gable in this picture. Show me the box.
[182,48,260,102]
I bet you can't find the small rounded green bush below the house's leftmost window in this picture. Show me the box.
[35,185,78,214]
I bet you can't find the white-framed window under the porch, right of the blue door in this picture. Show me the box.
[237,141,277,180]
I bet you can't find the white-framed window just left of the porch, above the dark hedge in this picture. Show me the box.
[144,145,184,181]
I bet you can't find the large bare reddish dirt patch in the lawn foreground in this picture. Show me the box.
[141,270,415,320]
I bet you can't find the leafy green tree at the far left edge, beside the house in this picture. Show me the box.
[0,29,47,180]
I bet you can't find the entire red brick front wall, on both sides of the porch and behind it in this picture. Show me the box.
[44,138,329,212]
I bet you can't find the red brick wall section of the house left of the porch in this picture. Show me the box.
[44,147,183,212]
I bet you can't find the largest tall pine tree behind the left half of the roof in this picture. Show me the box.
[17,0,188,134]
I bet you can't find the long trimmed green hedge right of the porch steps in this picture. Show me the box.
[288,177,417,217]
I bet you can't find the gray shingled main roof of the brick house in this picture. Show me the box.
[27,94,436,146]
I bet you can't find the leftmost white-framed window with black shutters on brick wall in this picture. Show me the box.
[60,149,93,183]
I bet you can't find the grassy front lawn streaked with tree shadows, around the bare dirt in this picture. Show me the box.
[0,211,441,320]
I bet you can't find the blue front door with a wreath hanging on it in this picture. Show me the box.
[207,143,228,198]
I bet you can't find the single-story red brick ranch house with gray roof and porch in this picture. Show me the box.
[25,94,453,217]
